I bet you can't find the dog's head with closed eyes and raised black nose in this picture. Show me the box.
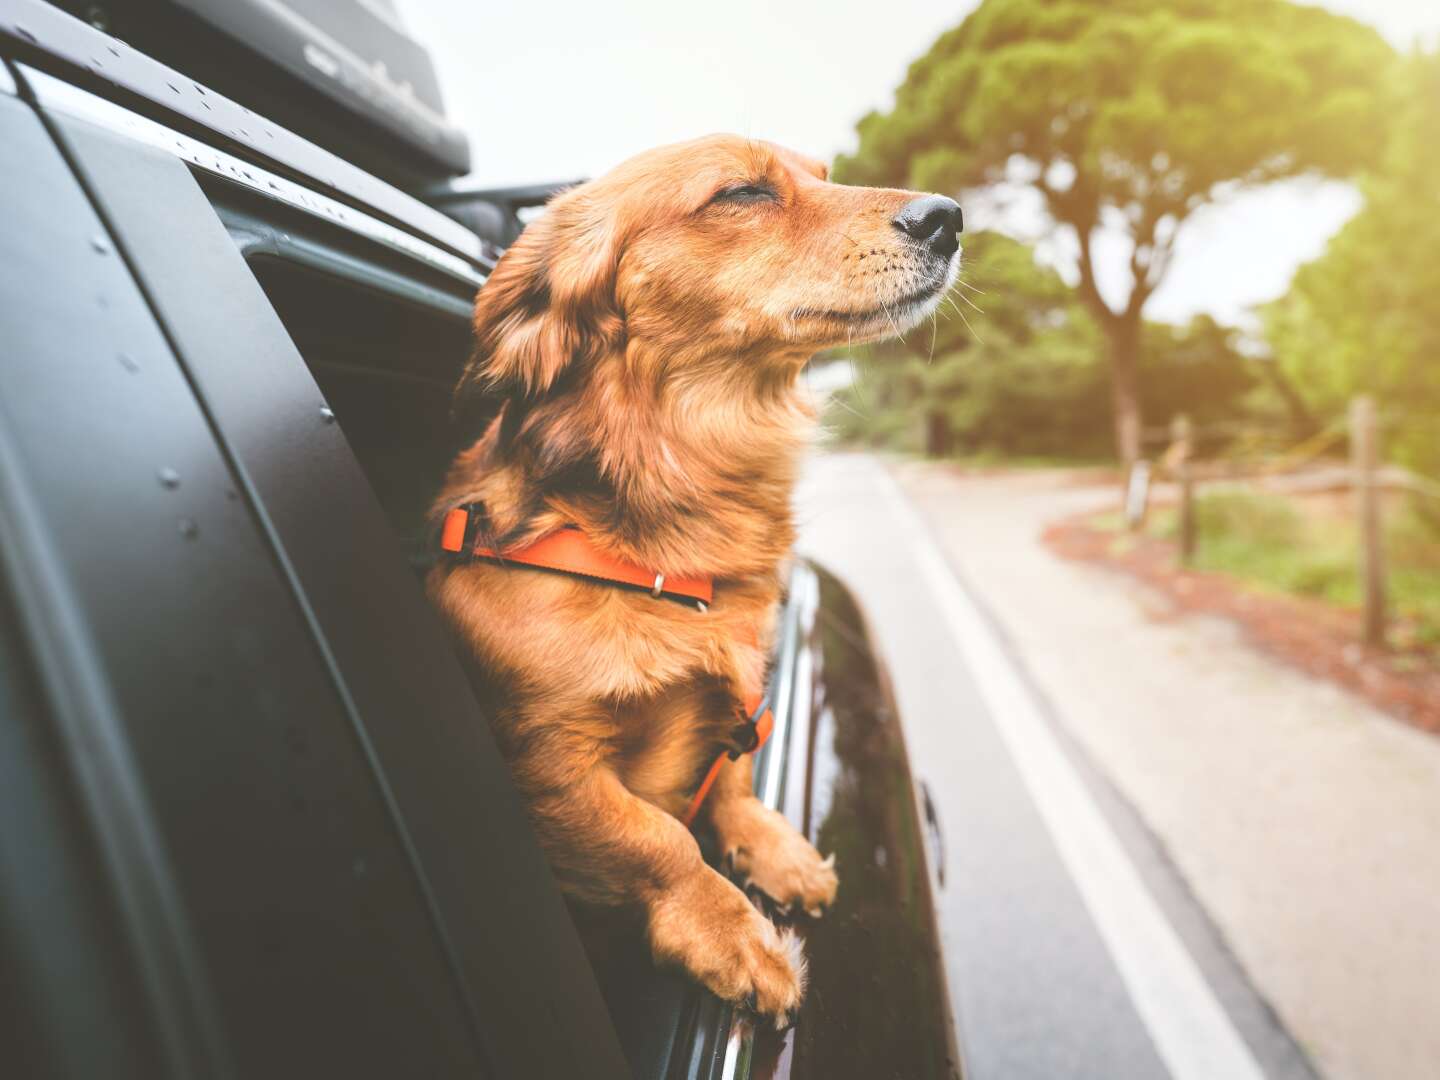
[461,135,960,414]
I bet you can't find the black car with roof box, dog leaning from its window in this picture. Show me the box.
[0,0,960,1080]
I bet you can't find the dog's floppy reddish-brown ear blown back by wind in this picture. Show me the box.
[455,187,622,429]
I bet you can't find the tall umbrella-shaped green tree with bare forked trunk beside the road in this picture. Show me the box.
[835,0,1392,465]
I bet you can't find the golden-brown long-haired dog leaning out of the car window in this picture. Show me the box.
[429,135,960,1021]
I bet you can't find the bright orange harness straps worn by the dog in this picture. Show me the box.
[441,507,775,825]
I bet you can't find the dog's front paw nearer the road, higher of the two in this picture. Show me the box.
[714,798,840,919]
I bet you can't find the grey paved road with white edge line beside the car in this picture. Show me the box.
[799,455,1313,1080]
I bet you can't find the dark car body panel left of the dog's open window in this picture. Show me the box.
[0,46,625,1076]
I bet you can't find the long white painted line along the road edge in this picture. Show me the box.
[874,465,1264,1080]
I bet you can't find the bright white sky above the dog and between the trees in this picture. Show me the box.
[399,0,1440,328]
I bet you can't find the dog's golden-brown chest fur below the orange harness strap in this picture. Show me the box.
[431,562,779,812]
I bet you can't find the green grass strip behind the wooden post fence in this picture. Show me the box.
[1123,492,1440,647]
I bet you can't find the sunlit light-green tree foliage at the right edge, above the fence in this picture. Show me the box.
[1263,52,1440,475]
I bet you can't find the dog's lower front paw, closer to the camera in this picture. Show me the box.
[648,867,805,1030]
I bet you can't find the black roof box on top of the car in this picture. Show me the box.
[74,0,469,187]
